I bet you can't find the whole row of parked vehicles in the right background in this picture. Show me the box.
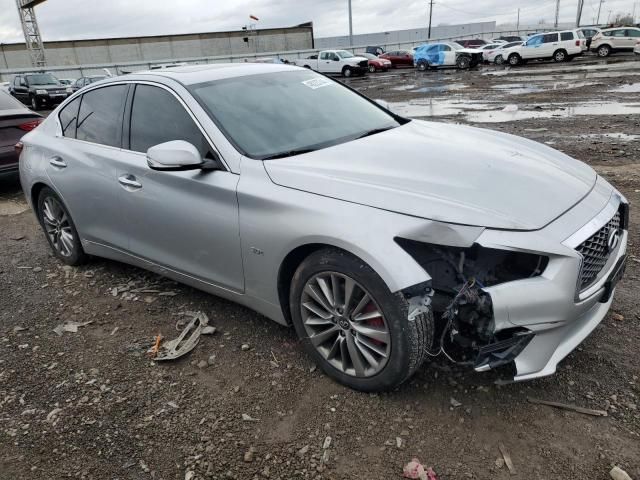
[292,27,640,77]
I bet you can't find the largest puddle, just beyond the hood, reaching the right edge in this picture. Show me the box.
[389,98,640,123]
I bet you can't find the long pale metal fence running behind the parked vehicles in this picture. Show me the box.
[0,28,549,82]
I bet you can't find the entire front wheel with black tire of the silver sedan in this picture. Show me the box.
[289,248,434,392]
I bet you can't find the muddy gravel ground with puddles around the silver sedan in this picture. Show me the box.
[0,56,640,480]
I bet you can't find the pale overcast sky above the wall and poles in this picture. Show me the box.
[0,0,640,43]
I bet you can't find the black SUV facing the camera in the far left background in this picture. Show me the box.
[9,73,73,110]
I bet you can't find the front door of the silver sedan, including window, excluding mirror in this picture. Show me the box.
[117,84,244,291]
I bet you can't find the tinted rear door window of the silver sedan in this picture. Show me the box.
[76,85,127,148]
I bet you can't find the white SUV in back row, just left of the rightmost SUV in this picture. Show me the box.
[505,30,587,65]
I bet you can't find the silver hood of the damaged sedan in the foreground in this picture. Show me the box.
[264,120,597,230]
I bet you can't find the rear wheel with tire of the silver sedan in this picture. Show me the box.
[37,187,88,266]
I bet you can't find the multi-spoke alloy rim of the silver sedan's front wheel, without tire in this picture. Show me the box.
[300,272,391,377]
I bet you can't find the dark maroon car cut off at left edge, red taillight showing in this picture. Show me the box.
[0,91,42,174]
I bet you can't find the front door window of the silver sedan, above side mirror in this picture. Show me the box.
[129,85,213,158]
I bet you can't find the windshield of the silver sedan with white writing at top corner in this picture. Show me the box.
[189,70,400,159]
